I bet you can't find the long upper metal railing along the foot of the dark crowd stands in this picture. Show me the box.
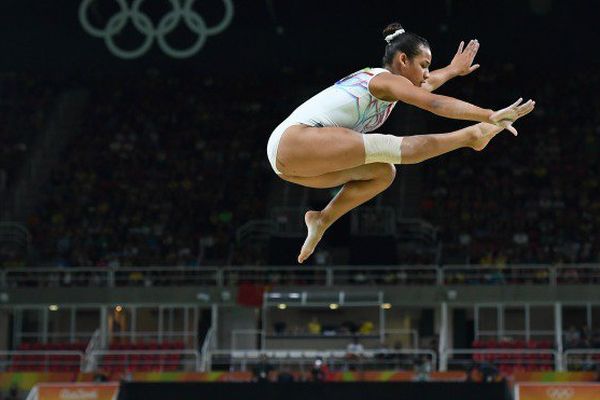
[0,264,600,288]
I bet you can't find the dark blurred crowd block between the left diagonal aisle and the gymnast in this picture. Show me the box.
[22,70,284,267]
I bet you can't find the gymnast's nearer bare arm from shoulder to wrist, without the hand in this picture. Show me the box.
[369,74,494,123]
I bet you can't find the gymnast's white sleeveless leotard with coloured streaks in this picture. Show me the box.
[267,68,396,174]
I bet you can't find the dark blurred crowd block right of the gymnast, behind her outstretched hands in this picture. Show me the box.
[421,64,600,266]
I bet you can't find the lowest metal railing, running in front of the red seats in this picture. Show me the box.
[0,349,600,372]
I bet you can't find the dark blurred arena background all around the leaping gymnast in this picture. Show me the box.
[0,0,600,398]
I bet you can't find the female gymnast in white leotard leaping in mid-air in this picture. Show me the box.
[267,23,535,263]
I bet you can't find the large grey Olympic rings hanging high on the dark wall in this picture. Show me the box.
[79,0,233,59]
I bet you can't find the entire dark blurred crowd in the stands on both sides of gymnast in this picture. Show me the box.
[0,64,600,268]
